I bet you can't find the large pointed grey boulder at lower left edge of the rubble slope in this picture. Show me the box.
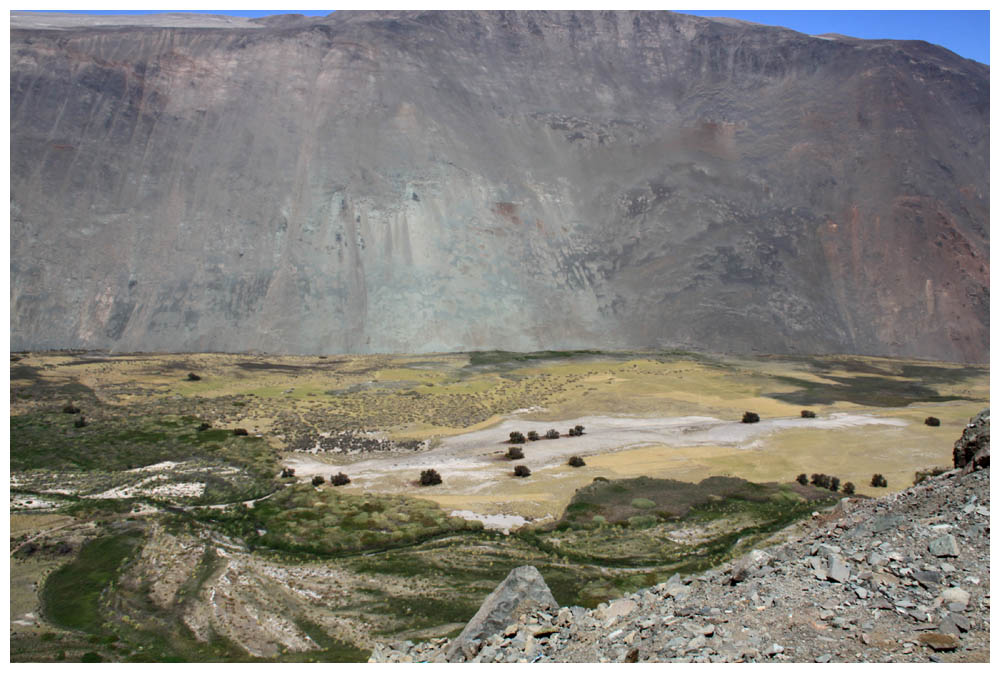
[448,566,559,660]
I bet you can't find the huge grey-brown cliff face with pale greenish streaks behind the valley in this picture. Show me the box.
[11,12,989,362]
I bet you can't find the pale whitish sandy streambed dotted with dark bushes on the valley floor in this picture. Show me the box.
[284,413,910,528]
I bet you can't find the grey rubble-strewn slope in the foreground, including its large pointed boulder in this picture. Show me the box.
[371,411,990,662]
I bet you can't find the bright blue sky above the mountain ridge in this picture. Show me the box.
[19,8,990,64]
